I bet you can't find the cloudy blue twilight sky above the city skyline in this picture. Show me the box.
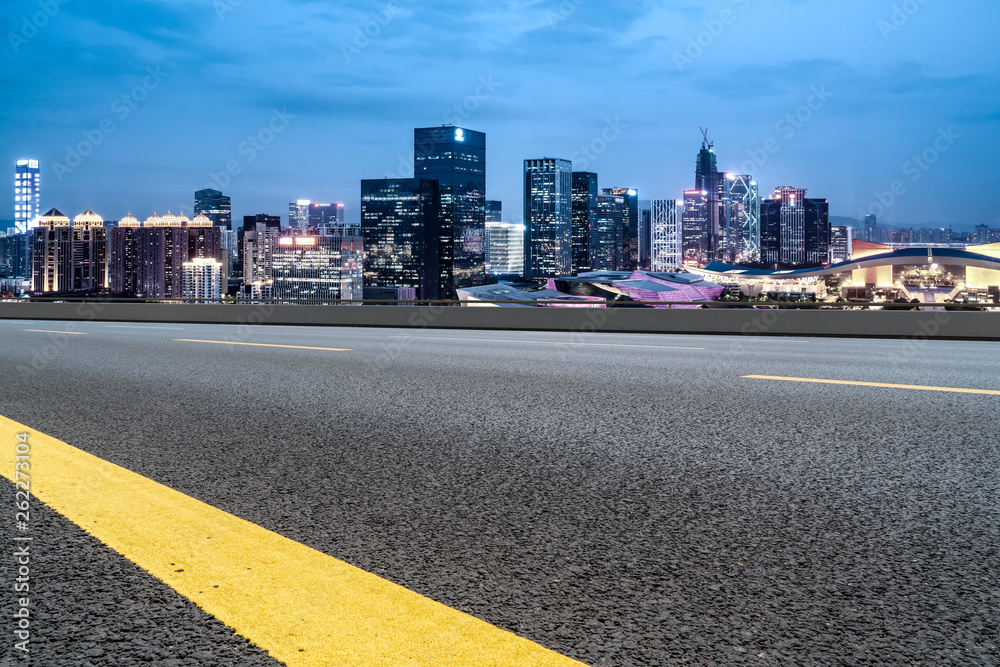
[0,0,1000,227]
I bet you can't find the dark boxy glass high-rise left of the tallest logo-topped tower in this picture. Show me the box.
[361,178,438,299]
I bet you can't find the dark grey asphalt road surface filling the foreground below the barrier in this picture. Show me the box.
[0,321,1000,667]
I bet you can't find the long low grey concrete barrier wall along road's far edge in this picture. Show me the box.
[0,303,1000,340]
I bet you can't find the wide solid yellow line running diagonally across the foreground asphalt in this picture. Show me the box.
[0,417,582,667]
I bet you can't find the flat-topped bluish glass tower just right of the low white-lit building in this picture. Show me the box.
[524,158,573,280]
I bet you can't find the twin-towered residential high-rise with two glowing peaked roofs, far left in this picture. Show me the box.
[31,209,108,293]
